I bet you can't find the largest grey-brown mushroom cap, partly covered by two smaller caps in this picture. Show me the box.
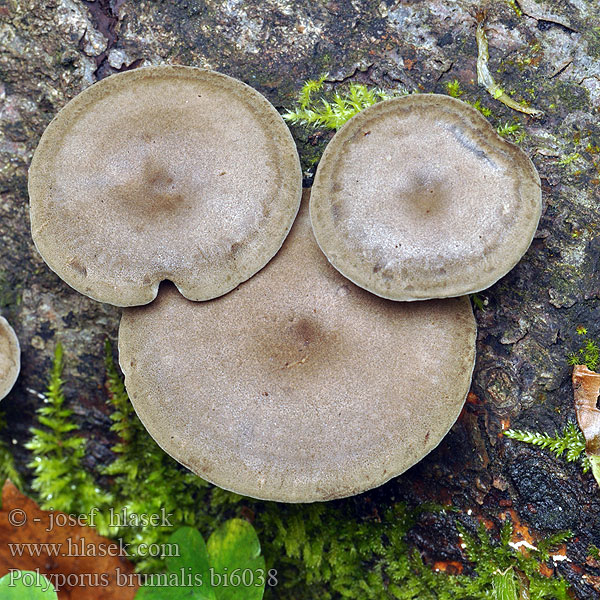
[119,191,476,502]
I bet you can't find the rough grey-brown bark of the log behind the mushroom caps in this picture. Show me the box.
[0,0,600,598]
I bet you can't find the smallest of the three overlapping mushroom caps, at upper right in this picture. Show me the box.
[310,94,542,300]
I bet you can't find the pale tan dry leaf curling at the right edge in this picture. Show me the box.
[573,365,600,485]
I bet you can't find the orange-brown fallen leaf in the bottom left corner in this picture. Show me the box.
[0,480,137,600]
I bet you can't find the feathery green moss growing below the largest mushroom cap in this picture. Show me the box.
[0,344,566,600]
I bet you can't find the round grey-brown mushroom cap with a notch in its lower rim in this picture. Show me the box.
[29,66,302,306]
